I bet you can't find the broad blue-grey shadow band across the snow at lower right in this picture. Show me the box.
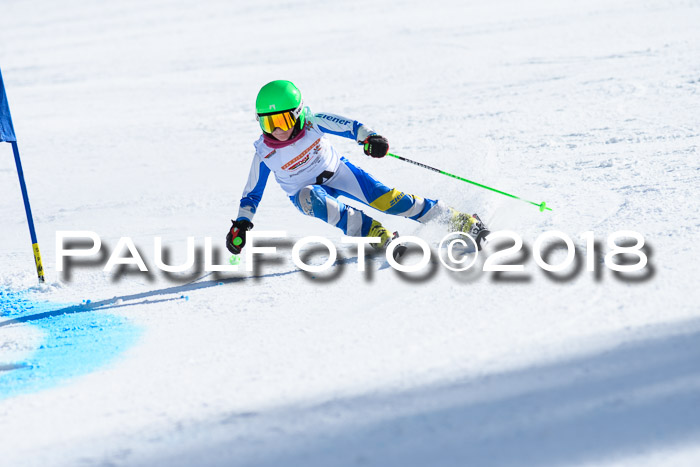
[170,320,700,466]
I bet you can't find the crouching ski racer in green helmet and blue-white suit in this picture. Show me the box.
[226,80,489,254]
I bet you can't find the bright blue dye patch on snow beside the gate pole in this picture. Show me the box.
[0,290,141,400]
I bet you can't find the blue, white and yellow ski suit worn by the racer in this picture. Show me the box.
[237,107,447,236]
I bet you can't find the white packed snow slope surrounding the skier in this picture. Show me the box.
[0,0,700,466]
